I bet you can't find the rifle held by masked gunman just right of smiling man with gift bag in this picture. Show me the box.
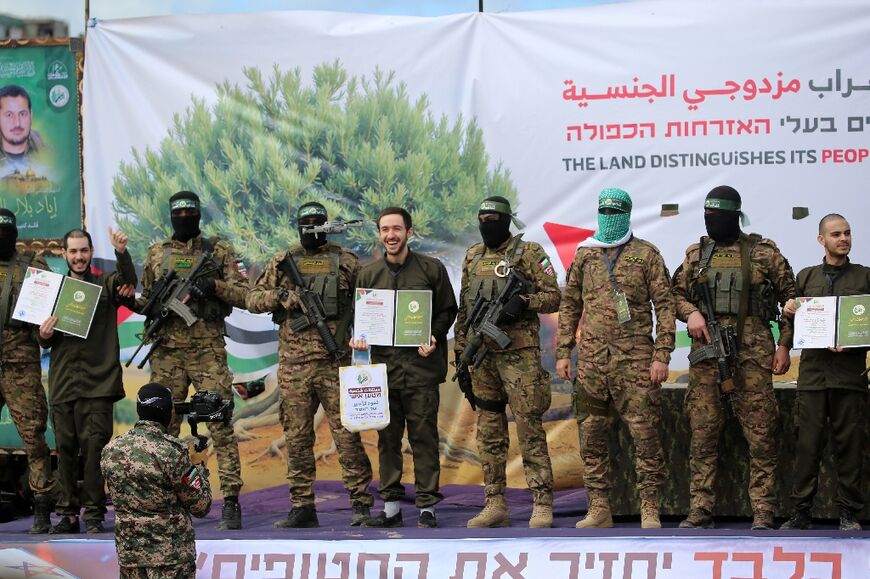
[453,268,528,410]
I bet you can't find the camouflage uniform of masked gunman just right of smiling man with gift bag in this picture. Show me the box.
[455,236,560,505]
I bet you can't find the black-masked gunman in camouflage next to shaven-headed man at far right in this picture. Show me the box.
[673,185,795,530]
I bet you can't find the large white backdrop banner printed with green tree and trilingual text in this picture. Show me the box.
[83,0,870,369]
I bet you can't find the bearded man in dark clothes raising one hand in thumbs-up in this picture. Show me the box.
[39,228,136,534]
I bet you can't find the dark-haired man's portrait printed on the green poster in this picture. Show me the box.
[0,84,43,174]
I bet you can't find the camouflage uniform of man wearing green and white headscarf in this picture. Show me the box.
[556,237,676,501]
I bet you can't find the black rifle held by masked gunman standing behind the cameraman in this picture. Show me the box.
[124,252,217,369]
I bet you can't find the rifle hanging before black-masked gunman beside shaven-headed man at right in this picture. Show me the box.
[689,277,738,417]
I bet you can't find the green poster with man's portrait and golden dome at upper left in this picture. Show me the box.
[0,44,82,240]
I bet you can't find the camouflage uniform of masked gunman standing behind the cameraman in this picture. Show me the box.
[137,236,247,497]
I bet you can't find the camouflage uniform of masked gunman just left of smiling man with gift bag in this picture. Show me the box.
[246,243,374,508]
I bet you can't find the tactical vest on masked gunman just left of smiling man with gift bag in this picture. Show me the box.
[272,243,348,328]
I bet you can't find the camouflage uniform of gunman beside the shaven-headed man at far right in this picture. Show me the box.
[673,234,795,514]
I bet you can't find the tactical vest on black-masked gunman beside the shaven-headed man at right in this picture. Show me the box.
[694,234,779,322]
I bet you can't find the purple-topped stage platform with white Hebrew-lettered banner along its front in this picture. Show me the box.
[0,482,870,579]
